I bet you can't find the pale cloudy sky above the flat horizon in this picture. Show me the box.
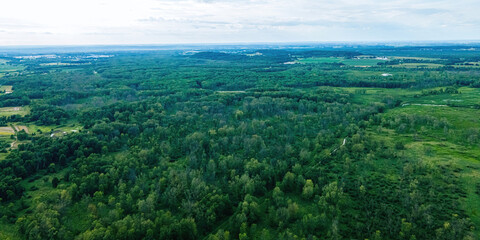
[0,0,480,46]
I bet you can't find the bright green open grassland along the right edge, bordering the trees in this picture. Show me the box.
[356,87,480,236]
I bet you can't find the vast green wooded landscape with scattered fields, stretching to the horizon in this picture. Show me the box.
[0,45,480,240]
